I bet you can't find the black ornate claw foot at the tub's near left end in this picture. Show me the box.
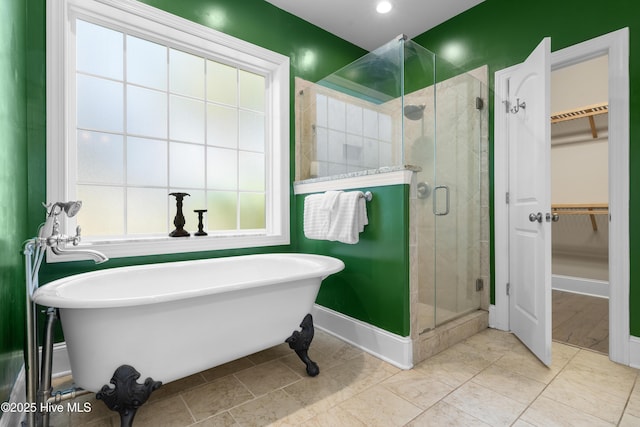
[96,365,162,427]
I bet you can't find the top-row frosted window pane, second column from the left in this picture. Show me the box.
[127,36,167,90]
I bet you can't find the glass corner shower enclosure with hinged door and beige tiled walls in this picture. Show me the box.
[296,37,489,352]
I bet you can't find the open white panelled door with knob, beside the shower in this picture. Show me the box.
[506,38,551,365]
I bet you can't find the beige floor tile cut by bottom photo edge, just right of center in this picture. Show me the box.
[340,385,422,427]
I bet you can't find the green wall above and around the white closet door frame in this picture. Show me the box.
[414,0,640,336]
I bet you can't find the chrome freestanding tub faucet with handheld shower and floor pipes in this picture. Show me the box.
[23,201,108,427]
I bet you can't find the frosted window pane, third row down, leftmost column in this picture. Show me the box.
[78,131,124,184]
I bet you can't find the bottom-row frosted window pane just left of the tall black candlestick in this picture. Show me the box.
[127,188,169,234]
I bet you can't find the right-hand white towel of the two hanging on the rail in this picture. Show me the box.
[327,191,369,245]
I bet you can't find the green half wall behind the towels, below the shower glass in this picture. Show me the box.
[296,185,410,336]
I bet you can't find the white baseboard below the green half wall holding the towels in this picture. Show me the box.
[311,304,413,369]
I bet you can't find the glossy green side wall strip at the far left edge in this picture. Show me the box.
[0,0,27,408]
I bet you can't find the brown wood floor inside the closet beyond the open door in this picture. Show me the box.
[552,290,609,354]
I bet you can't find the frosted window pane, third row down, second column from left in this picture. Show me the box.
[127,137,168,187]
